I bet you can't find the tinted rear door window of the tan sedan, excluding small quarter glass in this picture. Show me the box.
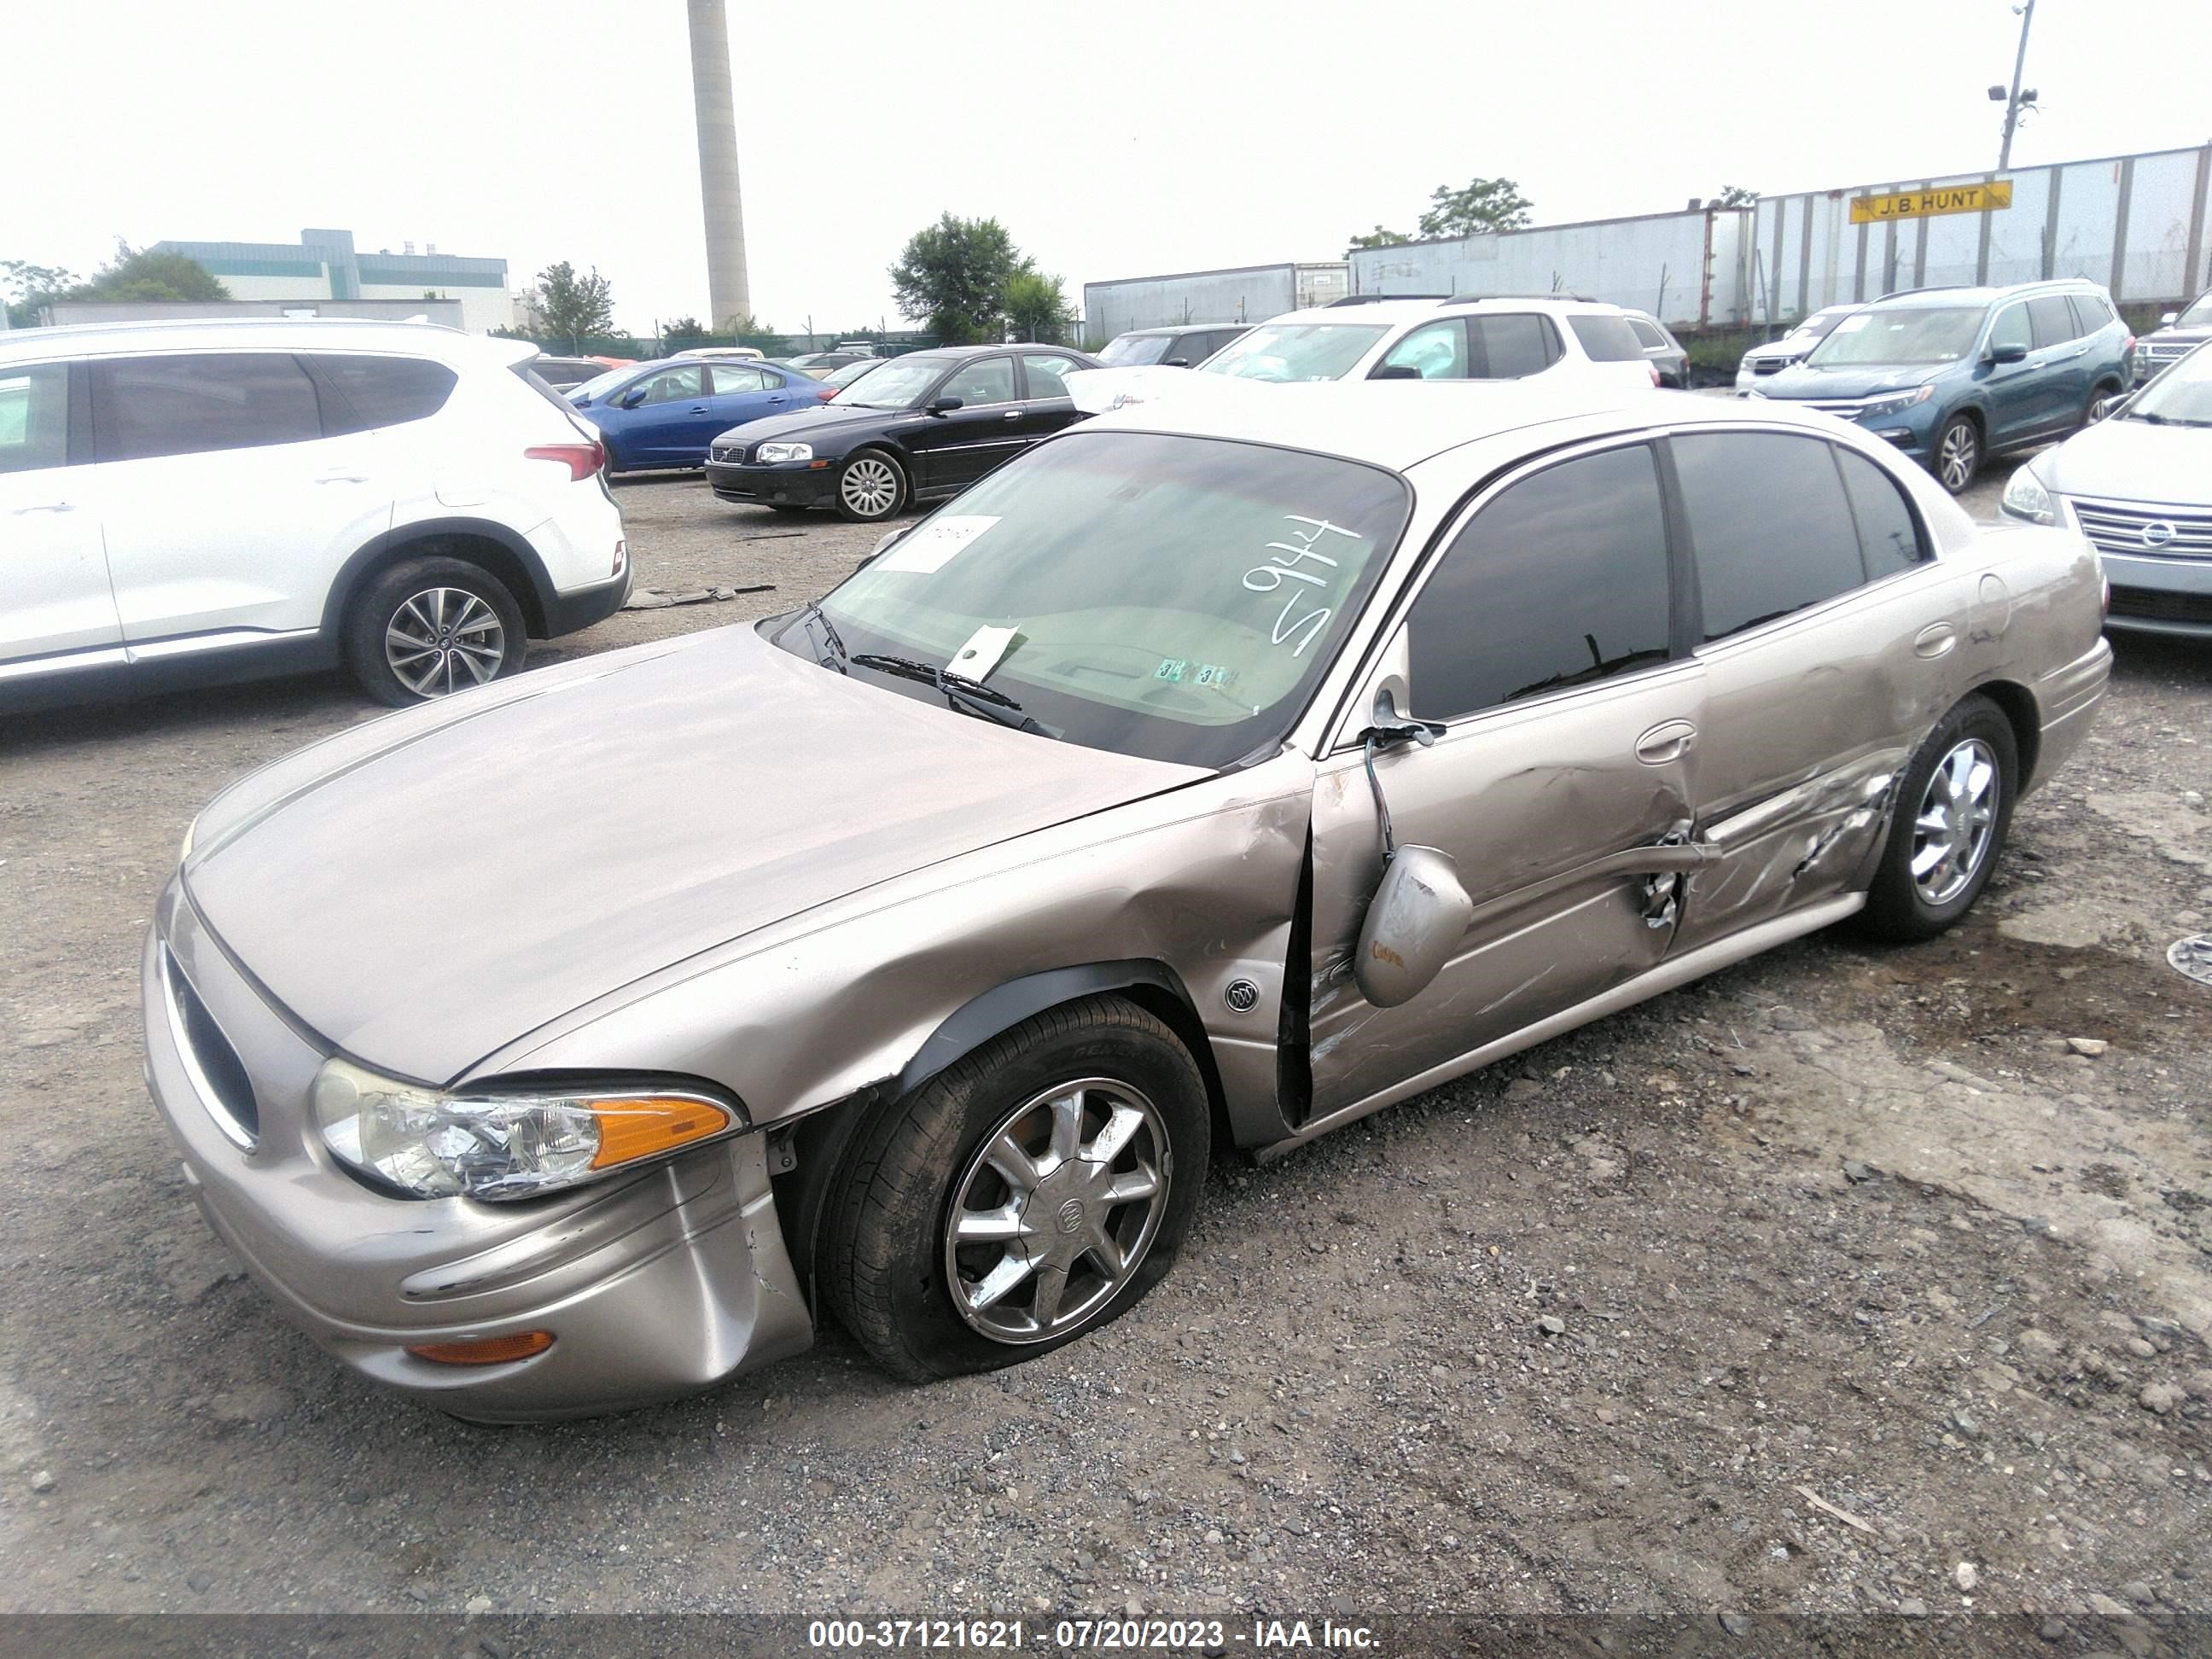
[1673,431,1867,639]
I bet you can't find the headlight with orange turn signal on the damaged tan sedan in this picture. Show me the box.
[314,1060,746,1199]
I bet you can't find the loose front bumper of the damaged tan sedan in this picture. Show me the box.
[142,881,814,1423]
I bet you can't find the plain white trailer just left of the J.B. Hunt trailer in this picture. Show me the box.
[1349,208,1752,329]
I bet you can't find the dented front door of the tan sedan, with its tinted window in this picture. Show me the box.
[1307,442,1705,1126]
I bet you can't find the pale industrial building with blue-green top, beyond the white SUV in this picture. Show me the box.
[153,230,515,334]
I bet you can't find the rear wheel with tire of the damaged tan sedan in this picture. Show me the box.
[1862,695,2019,945]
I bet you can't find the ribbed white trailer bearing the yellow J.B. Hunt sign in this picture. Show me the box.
[1752,143,2212,325]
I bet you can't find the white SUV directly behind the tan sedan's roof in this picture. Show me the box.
[1196,299,1659,389]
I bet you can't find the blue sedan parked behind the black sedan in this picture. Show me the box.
[568,356,836,474]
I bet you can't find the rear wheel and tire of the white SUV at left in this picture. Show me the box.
[345,557,527,707]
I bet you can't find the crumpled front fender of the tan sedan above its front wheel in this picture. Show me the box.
[475,752,1312,1146]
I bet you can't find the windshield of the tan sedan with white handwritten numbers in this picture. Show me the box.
[796,431,1412,767]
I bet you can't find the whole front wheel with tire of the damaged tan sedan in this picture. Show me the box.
[823,995,1212,1382]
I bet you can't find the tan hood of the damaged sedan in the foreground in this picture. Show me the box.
[183,626,1208,1084]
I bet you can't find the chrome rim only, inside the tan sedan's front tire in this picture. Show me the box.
[945,1077,1173,1345]
